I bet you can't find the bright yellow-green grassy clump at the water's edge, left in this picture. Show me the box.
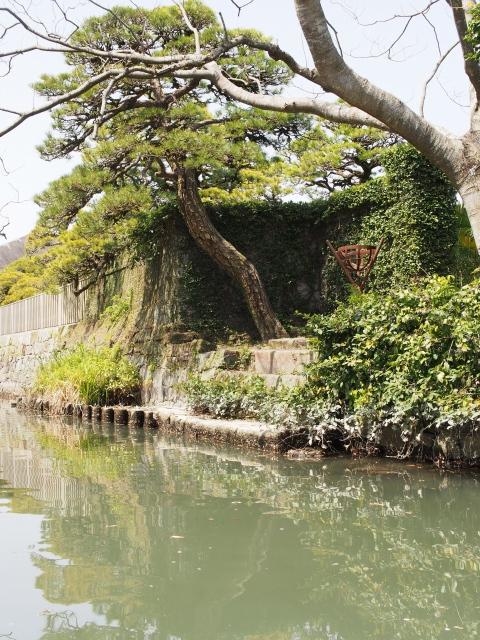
[34,345,140,408]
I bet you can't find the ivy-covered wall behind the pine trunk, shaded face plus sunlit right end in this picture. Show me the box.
[174,145,459,335]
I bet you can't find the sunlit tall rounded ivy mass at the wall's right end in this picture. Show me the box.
[360,145,459,289]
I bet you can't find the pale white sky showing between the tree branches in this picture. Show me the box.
[0,0,468,245]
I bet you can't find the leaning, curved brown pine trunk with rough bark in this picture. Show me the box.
[176,167,287,340]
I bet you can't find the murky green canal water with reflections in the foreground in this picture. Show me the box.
[0,409,480,640]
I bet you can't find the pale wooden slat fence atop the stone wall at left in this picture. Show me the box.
[0,285,88,336]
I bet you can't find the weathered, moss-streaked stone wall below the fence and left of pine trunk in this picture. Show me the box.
[0,220,193,403]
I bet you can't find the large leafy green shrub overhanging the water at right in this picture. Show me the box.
[305,277,480,426]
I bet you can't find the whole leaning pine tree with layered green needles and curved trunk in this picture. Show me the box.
[0,0,472,337]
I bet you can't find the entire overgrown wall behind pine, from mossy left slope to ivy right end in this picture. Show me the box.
[78,145,459,341]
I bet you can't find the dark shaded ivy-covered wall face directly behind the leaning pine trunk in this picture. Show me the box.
[181,201,352,335]
